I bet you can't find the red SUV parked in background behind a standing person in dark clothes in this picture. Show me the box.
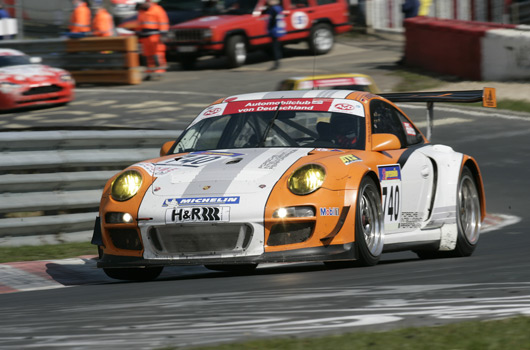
[166,0,351,69]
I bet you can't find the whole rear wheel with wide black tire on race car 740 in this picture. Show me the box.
[416,166,482,259]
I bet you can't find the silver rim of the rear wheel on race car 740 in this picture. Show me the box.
[458,174,480,245]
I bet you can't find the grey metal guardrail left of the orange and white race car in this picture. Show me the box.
[0,130,181,246]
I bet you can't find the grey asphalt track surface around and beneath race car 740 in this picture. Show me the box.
[0,35,530,349]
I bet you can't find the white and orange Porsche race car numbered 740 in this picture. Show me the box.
[92,90,494,280]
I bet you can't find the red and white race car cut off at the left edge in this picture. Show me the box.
[0,49,75,111]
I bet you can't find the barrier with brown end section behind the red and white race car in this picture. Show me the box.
[0,36,142,84]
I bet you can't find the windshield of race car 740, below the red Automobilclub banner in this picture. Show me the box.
[174,110,365,153]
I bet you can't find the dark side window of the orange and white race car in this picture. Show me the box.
[370,100,407,148]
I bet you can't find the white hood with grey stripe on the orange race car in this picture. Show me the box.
[142,148,311,198]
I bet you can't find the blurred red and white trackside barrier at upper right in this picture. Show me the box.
[405,17,530,81]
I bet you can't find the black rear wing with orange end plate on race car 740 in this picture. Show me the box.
[380,88,497,140]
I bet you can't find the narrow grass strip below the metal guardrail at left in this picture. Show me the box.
[0,242,97,263]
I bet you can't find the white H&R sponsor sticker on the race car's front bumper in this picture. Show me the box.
[166,207,230,223]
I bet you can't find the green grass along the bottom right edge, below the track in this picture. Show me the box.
[159,316,530,350]
